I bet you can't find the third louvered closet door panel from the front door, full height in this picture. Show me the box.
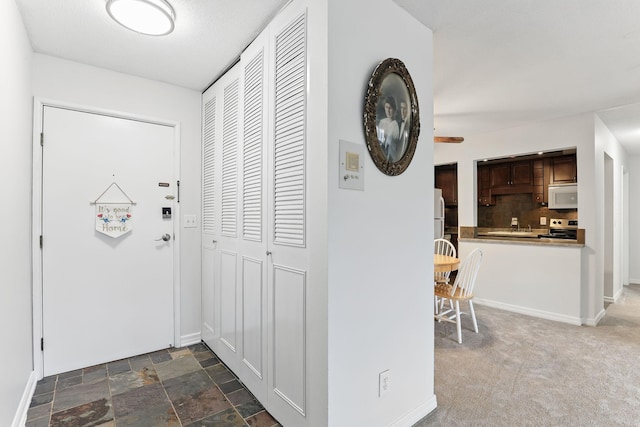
[237,30,268,404]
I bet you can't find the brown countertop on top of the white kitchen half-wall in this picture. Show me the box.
[458,227,584,247]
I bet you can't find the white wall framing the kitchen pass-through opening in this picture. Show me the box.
[434,113,604,324]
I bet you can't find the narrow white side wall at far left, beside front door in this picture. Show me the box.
[0,1,33,426]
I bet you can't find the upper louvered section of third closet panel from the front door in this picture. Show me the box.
[242,51,264,242]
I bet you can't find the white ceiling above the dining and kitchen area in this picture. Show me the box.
[395,0,640,154]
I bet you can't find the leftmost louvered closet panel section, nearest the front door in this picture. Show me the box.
[202,97,216,233]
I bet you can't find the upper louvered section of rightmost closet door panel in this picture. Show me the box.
[273,14,306,246]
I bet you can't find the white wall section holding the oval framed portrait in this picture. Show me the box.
[327,0,436,426]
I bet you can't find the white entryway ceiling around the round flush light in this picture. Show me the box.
[13,0,289,90]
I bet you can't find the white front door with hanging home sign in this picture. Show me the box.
[42,106,178,375]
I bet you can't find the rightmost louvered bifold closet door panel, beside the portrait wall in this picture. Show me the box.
[268,8,309,426]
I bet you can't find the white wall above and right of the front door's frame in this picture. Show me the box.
[33,54,201,341]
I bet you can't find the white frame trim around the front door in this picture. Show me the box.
[31,97,181,380]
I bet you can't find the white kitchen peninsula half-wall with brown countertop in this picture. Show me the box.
[458,227,585,325]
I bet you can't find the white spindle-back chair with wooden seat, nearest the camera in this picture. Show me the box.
[434,248,483,344]
